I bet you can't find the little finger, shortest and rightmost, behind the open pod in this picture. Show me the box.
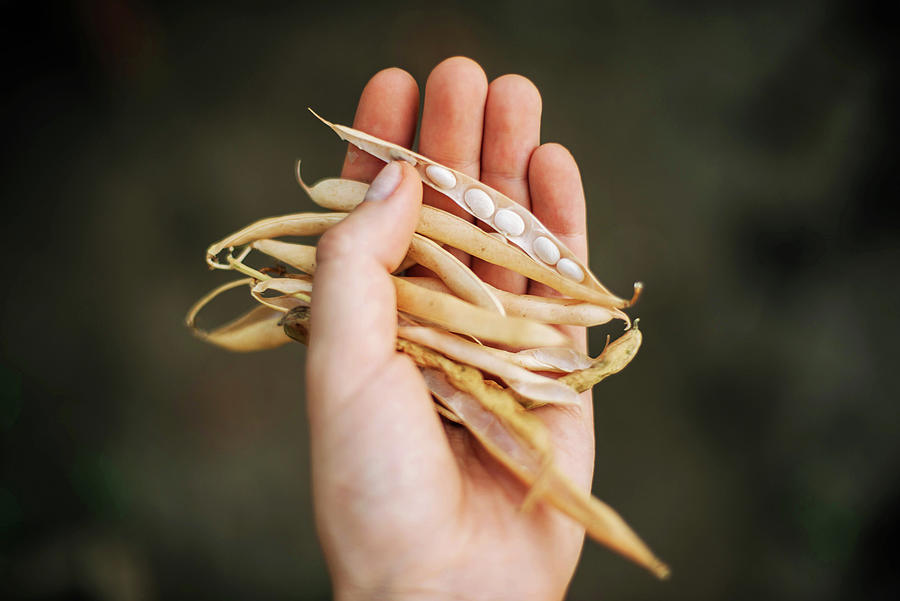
[528,144,587,350]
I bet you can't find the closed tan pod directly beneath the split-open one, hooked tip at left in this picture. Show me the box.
[298,173,641,310]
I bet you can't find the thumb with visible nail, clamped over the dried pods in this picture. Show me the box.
[307,162,422,408]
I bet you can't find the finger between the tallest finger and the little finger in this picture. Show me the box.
[472,75,541,294]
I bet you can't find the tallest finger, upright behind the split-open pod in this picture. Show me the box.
[410,56,488,275]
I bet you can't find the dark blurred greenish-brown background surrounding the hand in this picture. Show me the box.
[0,0,900,600]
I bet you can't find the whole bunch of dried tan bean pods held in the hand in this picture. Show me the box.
[187,115,669,578]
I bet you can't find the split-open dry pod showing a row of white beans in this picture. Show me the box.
[310,109,627,307]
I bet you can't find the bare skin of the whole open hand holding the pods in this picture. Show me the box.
[307,57,594,600]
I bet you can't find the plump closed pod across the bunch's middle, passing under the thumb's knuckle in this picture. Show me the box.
[252,240,571,348]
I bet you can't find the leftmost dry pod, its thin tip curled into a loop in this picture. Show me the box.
[185,278,290,352]
